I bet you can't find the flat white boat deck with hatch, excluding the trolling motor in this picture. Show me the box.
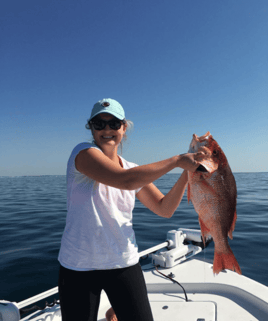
[19,259,268,321]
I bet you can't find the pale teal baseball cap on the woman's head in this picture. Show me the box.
[89,98,125,121]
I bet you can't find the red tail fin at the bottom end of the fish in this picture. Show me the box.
[213,246,242,274]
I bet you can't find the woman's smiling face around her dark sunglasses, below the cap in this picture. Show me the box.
[93,113,127,150]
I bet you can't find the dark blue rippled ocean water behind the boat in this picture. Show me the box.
[0,173,268,302]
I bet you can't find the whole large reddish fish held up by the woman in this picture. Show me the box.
[187,132,242,274]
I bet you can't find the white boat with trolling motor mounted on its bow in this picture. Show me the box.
[0,229,268,321]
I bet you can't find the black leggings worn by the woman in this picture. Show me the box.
[59,263,153,321]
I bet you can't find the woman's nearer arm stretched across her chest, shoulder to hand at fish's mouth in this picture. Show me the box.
[75,148,199,190]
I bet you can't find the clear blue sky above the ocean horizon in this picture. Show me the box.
[0,0,268,176]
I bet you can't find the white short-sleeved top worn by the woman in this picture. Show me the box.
[58,143,139,271]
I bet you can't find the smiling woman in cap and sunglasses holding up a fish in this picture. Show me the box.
[59,99,202,321]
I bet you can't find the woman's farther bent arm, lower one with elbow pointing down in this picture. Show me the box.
[136,170,188,218]
